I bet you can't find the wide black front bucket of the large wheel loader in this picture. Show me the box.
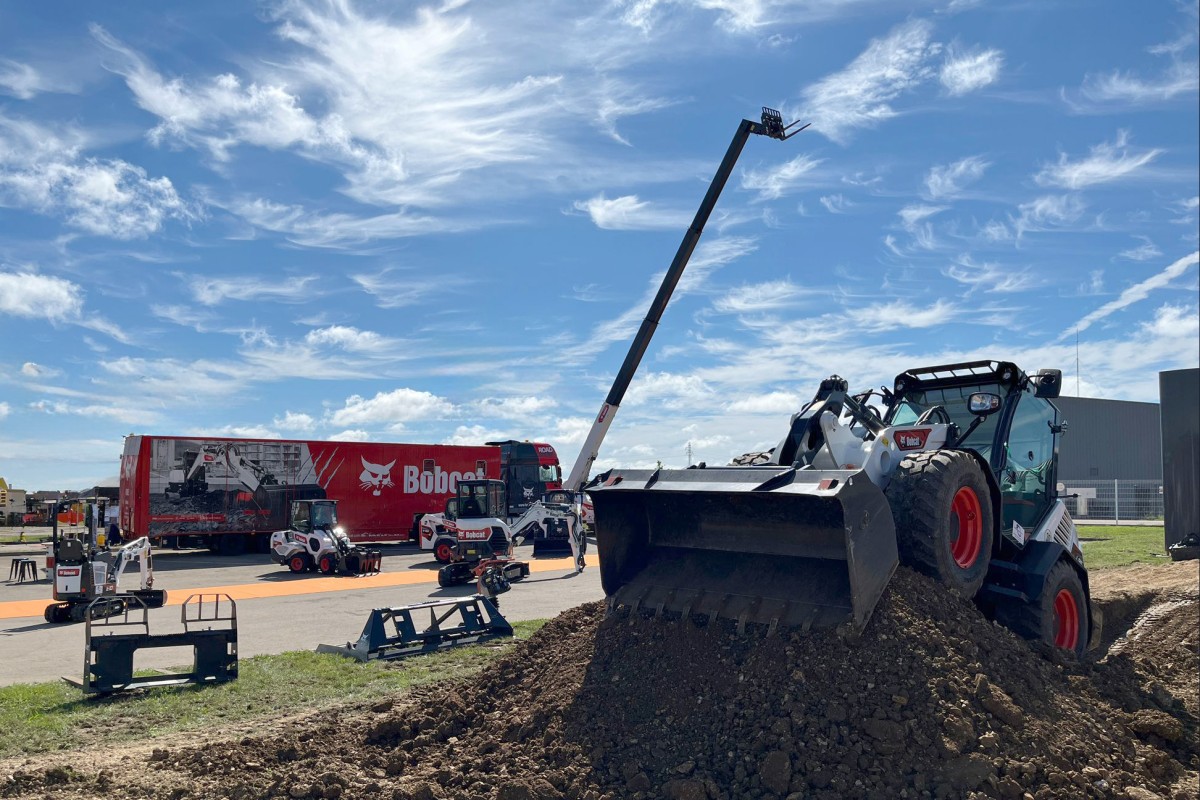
[588,465,898,631]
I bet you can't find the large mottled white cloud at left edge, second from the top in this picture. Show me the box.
[0,115,197,239]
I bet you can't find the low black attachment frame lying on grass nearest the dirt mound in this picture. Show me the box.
[317,595,512,661]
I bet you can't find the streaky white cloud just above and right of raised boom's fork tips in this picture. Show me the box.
[798,19,940,143]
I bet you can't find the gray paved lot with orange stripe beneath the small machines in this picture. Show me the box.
[0,543,604,686]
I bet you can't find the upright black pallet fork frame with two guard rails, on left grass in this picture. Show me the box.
[62,594,238,694]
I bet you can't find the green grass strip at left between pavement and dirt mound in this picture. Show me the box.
[0,620,545,758]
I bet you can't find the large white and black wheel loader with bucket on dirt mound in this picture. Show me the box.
[588,361,1099,652]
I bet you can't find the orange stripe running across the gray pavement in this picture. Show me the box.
[0,553,600,619]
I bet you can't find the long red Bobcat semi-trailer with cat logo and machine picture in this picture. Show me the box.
[120,435,508,554]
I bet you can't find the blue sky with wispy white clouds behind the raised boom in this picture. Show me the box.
[0,0,1200,489]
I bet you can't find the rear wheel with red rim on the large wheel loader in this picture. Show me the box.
[996,561,1091,656]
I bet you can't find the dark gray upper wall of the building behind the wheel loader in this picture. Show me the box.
[1055,397,1163,482]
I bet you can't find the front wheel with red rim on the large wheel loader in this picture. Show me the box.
[887,450,995,600]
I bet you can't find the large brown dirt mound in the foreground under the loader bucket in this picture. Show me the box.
[0,570,1200,800]
